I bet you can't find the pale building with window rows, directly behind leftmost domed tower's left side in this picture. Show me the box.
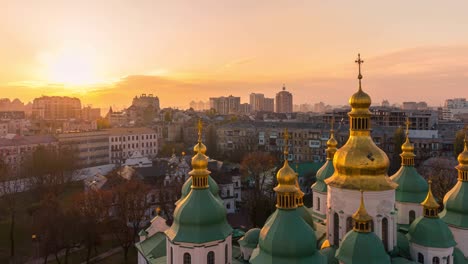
[105,127,158,163]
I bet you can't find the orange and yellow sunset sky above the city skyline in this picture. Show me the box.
[0,0,468,108]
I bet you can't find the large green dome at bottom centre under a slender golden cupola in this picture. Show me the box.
[250,209,326,264]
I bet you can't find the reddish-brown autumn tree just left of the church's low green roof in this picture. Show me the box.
[108,178,150,262]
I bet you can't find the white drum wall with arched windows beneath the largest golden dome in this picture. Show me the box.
[327,186,397,251]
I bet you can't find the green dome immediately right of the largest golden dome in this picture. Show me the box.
[390,166,429,204]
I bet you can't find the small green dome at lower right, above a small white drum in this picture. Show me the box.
[407,216,457,248]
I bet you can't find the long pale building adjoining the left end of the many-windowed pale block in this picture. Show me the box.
[57,130,110,168]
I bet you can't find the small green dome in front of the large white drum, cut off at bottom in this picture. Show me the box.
[336,231,390,264]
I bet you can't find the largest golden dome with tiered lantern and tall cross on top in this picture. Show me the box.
[325,55,397,191]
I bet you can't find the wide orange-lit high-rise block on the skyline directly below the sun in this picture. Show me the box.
[32,96,81,120]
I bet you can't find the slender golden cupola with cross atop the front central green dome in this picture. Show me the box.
[274,129,298,209]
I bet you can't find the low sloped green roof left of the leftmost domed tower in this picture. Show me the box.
[135,232,166,264]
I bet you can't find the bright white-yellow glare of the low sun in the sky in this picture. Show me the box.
[39,49,98,88]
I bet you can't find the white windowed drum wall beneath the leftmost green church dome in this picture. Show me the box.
[166,235,232,264]
